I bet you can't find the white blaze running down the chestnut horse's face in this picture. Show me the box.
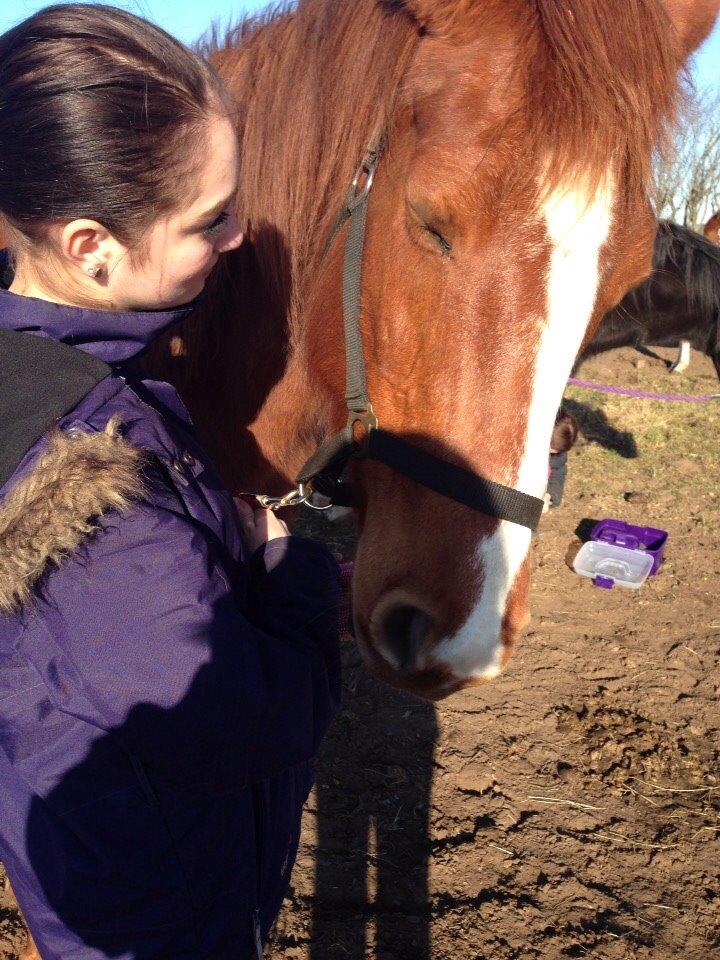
[433,180,613,678]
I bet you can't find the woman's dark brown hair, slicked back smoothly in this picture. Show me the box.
[0,4,222,244]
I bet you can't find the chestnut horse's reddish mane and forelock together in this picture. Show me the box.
[188,0,679,337]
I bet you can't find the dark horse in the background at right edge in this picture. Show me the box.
[577,221,720,377]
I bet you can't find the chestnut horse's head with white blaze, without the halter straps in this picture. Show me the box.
[312,0,718,698]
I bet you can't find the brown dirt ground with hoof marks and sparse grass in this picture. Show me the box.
[0,350,720,960]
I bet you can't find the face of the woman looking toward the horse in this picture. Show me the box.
[105,116,242,310]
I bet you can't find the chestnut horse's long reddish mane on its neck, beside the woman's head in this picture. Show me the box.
[201,0,417,333]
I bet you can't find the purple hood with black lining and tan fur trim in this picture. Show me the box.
[0,250,200,614]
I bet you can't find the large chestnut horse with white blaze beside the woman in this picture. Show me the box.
[149,0,720,698]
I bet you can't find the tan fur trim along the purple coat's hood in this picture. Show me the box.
[0,417,144,614]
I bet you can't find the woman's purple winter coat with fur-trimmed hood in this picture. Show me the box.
[0,268,340,960]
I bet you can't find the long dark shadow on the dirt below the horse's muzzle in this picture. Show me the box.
[310,640,438,960]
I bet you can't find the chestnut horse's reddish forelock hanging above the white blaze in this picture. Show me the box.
[401,0,681,202]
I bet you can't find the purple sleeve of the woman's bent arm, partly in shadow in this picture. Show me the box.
[31,504,340,789]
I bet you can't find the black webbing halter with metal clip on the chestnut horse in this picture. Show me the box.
[248,137,543,530]
